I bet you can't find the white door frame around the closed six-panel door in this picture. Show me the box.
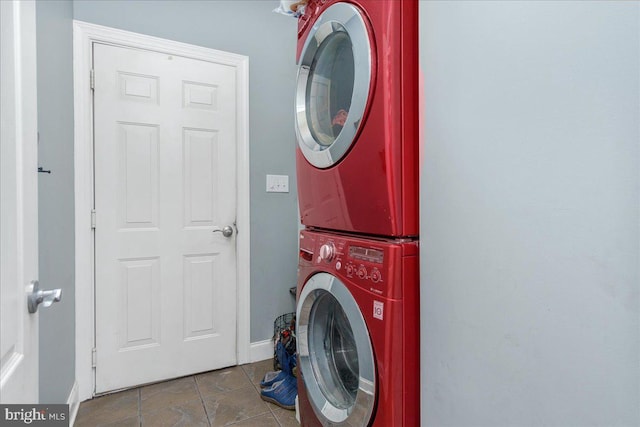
[73,20,251,401]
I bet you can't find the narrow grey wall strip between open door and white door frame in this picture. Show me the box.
[36,0,76,403]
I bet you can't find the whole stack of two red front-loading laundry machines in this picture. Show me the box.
[296,0,420,427]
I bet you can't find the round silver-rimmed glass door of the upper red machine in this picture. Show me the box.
[296,3,372,168]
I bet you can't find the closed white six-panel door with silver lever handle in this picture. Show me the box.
[93,43,237,393]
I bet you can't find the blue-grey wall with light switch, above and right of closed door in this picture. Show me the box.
[73,0,298,342]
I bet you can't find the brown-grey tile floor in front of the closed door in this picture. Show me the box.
[74,360,298,427]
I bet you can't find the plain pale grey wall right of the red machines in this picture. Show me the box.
[420,1,640,427]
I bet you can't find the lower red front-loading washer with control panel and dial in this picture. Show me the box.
[296,230,420,427]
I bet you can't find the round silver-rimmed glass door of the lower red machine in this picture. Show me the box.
[296,273,376,426]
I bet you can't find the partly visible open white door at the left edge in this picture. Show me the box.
[0,1,38,403]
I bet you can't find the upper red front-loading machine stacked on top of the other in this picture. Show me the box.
[296,0,419,237]
